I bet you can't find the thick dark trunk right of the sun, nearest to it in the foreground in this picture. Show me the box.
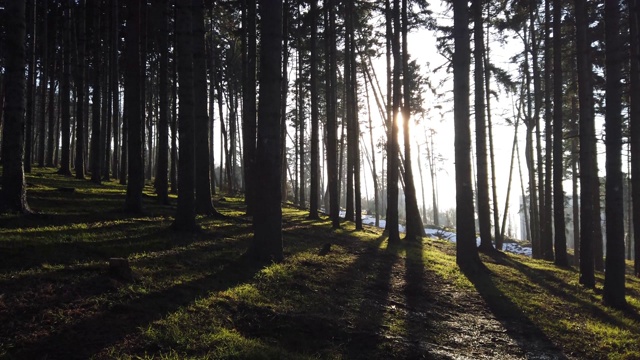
[453,0,482,272]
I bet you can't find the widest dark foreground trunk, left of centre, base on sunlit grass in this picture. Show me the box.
[248,0,284,262]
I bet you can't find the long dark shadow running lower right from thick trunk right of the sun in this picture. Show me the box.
[463,262,567,360]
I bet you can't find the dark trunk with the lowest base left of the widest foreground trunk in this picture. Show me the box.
[173,0,196,231]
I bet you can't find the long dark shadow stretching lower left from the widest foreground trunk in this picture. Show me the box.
[9,253,260,359]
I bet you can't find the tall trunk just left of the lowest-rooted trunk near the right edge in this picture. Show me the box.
[574,0,599,288]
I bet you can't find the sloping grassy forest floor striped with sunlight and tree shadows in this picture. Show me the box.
[0,169,640,359]
